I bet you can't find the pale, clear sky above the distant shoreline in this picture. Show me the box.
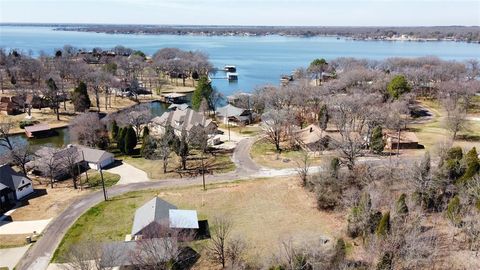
[0,0,480,26]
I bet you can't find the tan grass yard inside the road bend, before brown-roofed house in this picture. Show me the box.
[250,139,322,169]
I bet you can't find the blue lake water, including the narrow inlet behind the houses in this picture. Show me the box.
[0,26,480,150]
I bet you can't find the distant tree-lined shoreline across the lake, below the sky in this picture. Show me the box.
[0,23,480,44]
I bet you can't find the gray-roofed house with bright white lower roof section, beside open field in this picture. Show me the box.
[131,197,199,238]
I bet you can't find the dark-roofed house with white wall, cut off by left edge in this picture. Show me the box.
[0,165,33,200]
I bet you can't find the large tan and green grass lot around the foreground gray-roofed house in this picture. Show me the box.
[53,178,345,262]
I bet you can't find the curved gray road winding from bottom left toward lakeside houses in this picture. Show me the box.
[15,138,262,270]
